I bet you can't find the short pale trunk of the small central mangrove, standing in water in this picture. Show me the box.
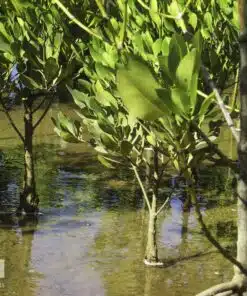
[145,193,158,264]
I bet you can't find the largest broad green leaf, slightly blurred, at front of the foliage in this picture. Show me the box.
[117,57,166,120]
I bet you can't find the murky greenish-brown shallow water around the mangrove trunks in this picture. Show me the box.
[0,108,236,296]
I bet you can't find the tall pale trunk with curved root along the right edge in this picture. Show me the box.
[198,0,247,296]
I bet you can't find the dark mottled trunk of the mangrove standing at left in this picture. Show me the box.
[18,105,39,213]
